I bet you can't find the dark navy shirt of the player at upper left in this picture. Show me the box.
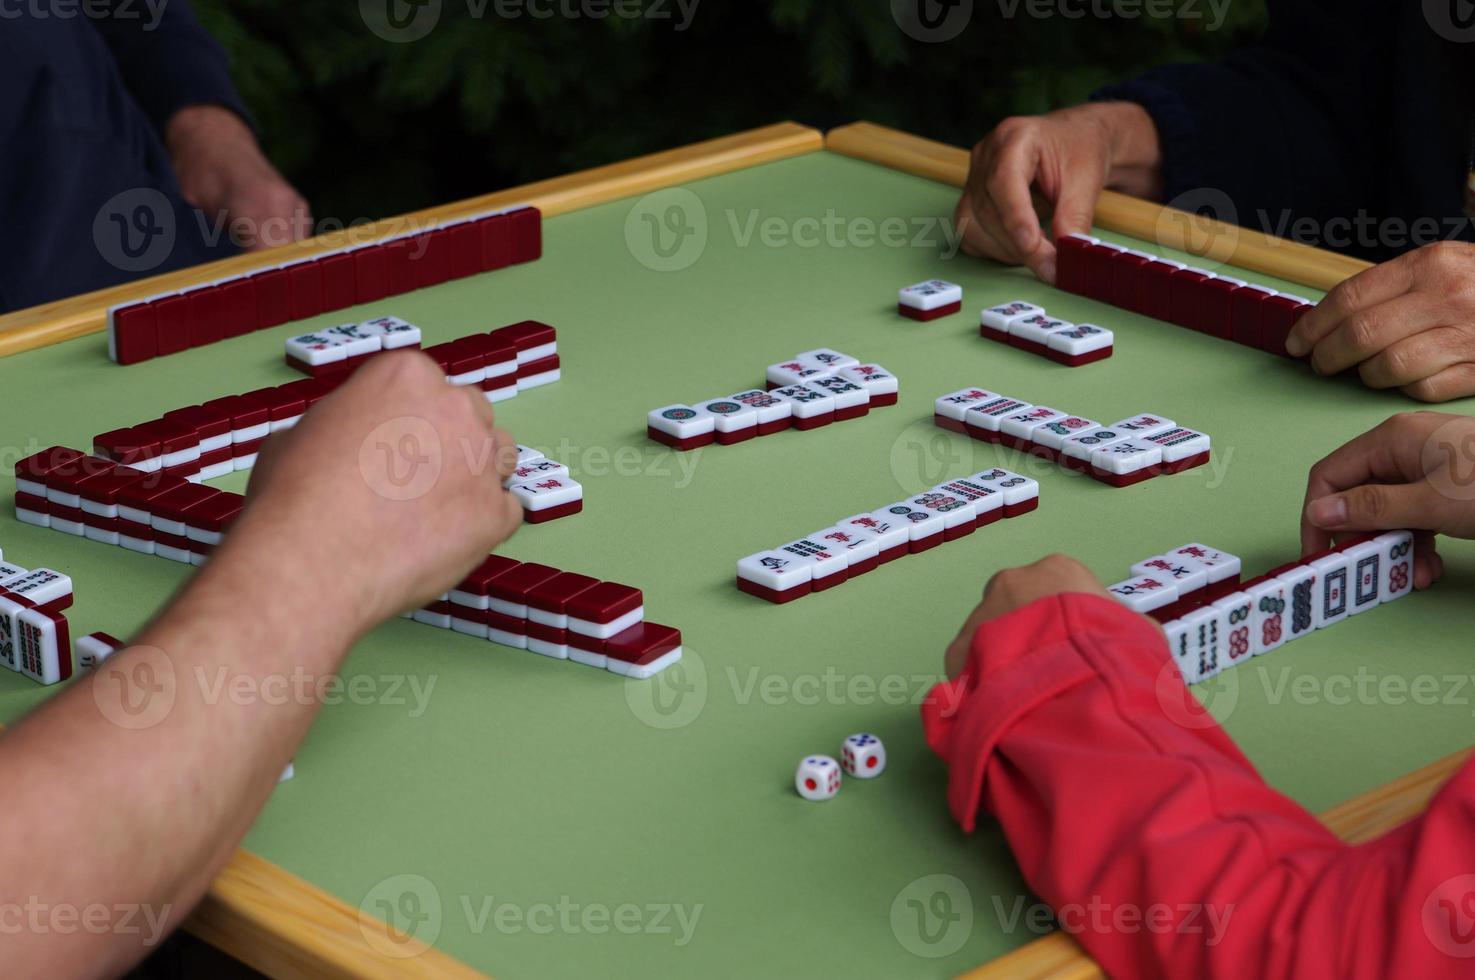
[0,0,245,310]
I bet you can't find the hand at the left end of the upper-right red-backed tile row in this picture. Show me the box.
[954,102,1162,283]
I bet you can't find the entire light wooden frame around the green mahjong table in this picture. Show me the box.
[0,123,1469,980]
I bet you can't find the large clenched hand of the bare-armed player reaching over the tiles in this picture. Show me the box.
[224,353,522,638]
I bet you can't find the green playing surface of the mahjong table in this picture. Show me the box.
[0,153,1475,977]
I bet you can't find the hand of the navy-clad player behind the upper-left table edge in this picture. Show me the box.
[165,105,313,251]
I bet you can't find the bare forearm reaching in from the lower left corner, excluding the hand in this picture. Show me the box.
[0,540,353,976]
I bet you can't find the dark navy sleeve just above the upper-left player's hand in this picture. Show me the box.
[93,0,251,133]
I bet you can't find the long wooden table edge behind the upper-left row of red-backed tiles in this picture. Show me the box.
[0,123,825,357]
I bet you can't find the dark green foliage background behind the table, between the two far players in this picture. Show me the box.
[195,0,1264,221]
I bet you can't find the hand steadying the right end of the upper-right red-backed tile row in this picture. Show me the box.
[1286,242,1475,401]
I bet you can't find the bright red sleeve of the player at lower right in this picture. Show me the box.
[922,595,1475,979]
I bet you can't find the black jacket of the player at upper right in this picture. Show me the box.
[1092,0,1472,254]
